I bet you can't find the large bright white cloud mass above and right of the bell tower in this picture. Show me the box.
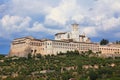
[43,0,120,37]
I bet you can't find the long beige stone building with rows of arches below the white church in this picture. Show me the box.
[10,37,99,57]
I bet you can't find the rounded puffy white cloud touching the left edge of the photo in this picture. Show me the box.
[0,15,31,37]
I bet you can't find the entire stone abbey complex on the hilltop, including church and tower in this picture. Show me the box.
[9,24,120,57]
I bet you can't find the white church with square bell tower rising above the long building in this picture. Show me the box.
[55,24,90,43]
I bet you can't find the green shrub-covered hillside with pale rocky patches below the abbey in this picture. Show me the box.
[0,50,120,80]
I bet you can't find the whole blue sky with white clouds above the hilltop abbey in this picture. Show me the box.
[0,0,120,54]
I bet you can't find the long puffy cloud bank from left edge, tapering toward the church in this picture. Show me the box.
[0,15,64,38]
